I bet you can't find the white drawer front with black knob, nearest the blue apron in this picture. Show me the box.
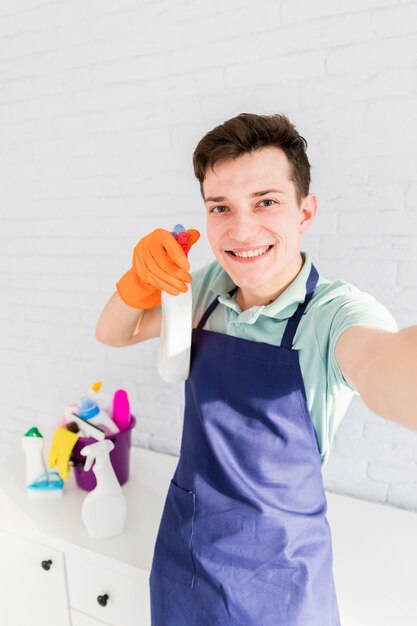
[66,555,151,626]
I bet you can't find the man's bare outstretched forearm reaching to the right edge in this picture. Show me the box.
[357,326,417,430]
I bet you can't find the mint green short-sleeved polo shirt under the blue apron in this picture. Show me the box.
[192,252,398,466]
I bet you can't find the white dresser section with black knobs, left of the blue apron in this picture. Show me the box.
[0,448,178,626]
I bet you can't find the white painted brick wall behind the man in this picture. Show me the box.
[0,0,417,510]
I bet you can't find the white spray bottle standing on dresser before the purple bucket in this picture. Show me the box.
[81,439,127,539]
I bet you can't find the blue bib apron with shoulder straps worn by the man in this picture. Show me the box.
[150,266,340,626]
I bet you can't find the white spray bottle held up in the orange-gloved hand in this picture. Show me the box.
[157,224,192,382]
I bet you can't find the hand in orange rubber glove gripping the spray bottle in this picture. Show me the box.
[116,228,200,309]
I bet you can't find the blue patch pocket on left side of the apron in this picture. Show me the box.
[152,480,195,587]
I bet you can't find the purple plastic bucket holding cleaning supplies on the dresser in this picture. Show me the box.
[71,415,136,491]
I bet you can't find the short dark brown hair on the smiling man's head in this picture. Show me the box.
[193,113,311,205]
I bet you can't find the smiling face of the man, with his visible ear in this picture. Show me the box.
[203,147,317,308]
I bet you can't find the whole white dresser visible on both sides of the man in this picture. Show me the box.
[0,448,417,626]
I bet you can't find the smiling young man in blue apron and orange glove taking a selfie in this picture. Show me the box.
[96,114,417,626]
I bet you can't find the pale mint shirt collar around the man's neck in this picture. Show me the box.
[209,252,311,323]
